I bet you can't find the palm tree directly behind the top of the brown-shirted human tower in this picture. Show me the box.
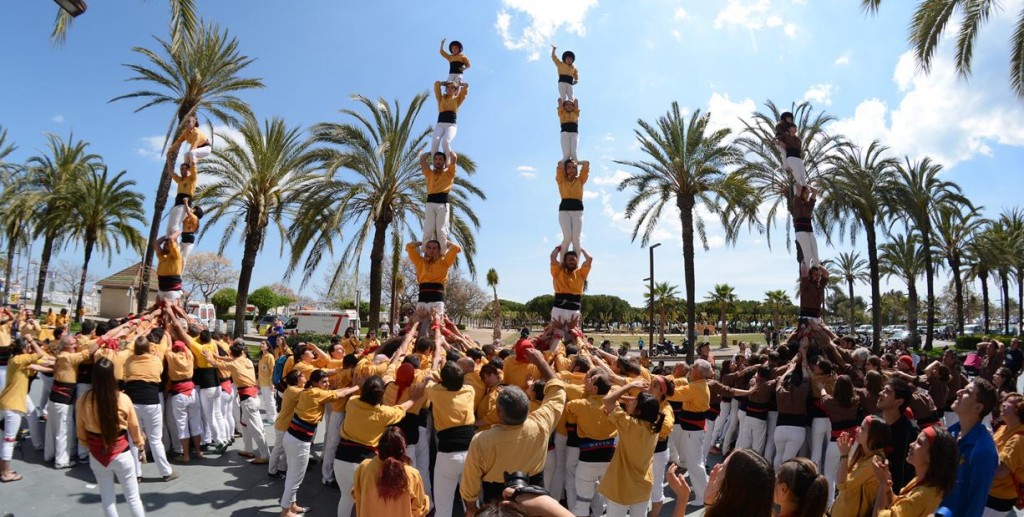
[733,100,850,250]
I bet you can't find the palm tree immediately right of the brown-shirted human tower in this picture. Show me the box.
[818,140,897,350]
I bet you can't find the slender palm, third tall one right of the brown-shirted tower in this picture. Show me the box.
[932,207,985,334]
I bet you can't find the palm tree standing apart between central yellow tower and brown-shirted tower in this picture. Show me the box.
[615,102,757,362]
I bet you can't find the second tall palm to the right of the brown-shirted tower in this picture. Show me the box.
[886,157,972,350]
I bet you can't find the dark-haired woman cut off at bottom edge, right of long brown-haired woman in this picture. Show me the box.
[775,458,831,517]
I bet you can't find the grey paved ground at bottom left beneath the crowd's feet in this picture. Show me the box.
[0,382,720,517]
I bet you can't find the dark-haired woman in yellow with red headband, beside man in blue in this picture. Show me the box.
[872,426,959,517]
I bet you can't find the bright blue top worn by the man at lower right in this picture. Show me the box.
[936,422,999,517]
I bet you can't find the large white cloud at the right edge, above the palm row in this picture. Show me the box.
[834,51,1024,167]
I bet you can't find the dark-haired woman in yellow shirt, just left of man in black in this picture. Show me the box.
[830,415,892,517]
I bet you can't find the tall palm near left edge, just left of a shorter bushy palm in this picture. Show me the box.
[15,134,103,313]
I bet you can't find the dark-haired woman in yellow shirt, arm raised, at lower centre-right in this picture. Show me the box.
[598,378,665,517]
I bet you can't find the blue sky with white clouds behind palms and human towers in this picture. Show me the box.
[0,0,1024,305]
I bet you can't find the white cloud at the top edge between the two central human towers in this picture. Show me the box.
[495,0,597,60]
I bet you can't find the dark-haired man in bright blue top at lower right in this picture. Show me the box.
[941,378,999,516]
